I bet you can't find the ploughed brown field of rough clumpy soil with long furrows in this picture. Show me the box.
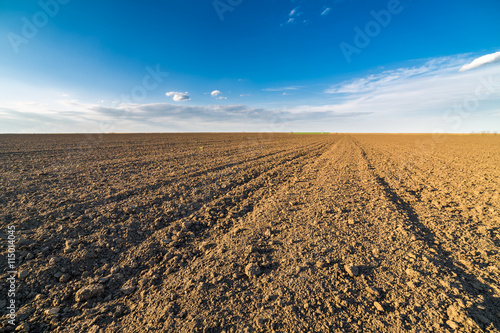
[0,133,500,332]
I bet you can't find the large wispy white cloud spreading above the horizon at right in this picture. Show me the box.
[321,57,500,129]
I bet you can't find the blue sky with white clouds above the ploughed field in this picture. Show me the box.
[0,0,500,133]
